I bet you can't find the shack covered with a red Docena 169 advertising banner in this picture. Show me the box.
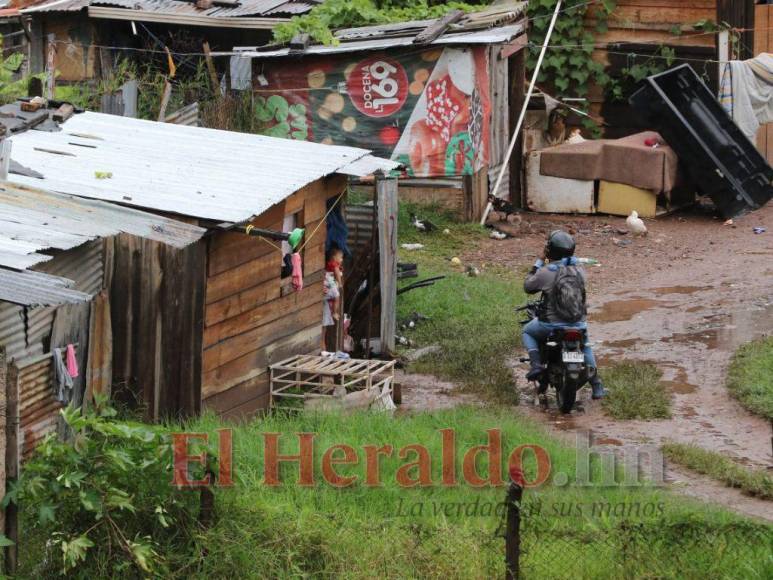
[231,2,526,220]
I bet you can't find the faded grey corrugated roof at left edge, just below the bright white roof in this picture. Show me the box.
[0,178,205,270]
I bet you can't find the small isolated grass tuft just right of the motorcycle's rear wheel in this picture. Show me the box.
[601,362,671,420]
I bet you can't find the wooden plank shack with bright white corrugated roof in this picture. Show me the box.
[13,113,397,419]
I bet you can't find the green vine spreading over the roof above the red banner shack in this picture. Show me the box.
[273,0,490,44]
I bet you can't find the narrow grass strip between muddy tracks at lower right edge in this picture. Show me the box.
[663,443,773,500]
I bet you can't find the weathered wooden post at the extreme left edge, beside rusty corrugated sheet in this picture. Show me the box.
[5,364,19,576]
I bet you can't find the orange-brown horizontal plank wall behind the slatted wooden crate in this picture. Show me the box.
[202,176,346,417]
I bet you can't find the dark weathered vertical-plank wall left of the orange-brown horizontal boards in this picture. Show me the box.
[110,234,207,420]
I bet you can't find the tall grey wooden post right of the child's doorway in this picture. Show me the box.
[376,176,397,354]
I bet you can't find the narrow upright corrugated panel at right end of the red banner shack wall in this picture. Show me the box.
[488,45,510,199]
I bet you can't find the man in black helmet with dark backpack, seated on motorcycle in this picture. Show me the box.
[523,230,606,399]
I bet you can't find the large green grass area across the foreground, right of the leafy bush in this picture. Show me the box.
[173,408,770,579]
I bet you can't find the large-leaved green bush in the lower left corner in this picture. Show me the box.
[10,402,207,578]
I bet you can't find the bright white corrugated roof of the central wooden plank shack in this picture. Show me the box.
[11,113,399,222]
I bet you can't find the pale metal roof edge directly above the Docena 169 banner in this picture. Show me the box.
[232,22,526,58]
